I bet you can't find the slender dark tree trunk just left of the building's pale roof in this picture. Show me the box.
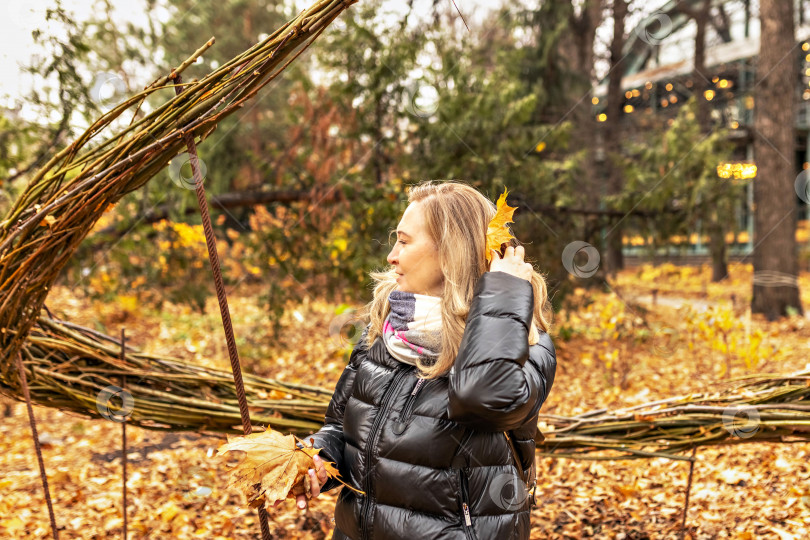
[605,0,627,274]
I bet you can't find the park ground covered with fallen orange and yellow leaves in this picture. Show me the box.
[0,264,810,540]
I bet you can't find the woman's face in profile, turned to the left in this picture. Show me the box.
[388,202,444,296]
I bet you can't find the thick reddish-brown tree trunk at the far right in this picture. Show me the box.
[751,0,803,320]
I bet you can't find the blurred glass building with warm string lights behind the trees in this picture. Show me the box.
[593,0,810,257]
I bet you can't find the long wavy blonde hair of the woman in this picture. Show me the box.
[363,180,550,379]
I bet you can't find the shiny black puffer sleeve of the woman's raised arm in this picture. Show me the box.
[448,271,556,431]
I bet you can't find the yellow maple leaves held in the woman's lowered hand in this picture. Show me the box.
[217,429,362,508]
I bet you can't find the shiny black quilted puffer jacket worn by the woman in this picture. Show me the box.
[307,271,557,540]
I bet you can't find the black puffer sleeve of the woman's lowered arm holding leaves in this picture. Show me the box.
[296,325,371,493]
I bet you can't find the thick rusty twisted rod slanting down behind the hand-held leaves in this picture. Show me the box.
[174,75,271,540]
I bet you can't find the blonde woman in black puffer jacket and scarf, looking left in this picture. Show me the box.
[272,181,556,540]
